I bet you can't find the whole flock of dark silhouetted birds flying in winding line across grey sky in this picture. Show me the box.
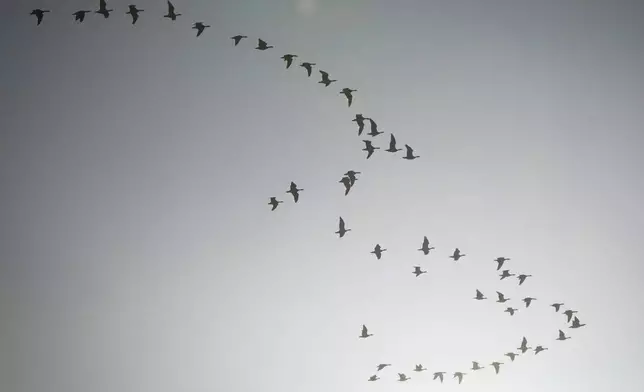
[30,0,586,384]
